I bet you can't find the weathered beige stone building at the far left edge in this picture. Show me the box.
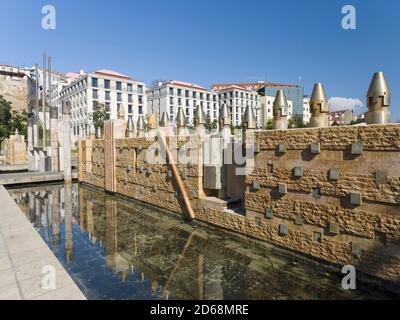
[0,65,36,111]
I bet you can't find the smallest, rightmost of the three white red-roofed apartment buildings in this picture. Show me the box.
[213,85,261,127]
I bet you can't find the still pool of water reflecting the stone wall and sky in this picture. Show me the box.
[10,184,394,300]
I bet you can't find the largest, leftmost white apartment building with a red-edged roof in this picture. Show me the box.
[57,70,147,139]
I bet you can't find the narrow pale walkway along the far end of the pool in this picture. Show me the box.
[0,172,64,185]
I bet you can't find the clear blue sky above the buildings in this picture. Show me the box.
[0,0,400,120]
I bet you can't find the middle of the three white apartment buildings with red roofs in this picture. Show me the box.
[147,80,219,126]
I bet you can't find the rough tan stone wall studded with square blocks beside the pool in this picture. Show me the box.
[79,125,400,284]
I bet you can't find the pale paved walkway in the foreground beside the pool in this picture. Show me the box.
[0,185,86,300]
